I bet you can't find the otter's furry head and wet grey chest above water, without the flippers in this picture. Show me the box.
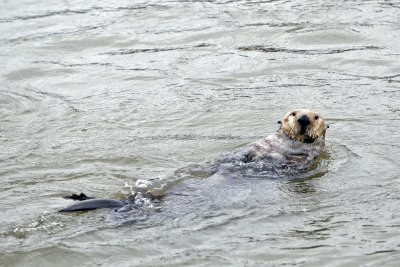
[218,109,327,170]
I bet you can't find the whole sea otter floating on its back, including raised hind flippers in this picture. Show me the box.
[60,109,328,212]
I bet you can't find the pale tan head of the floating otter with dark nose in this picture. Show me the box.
[281,109,327,143]
